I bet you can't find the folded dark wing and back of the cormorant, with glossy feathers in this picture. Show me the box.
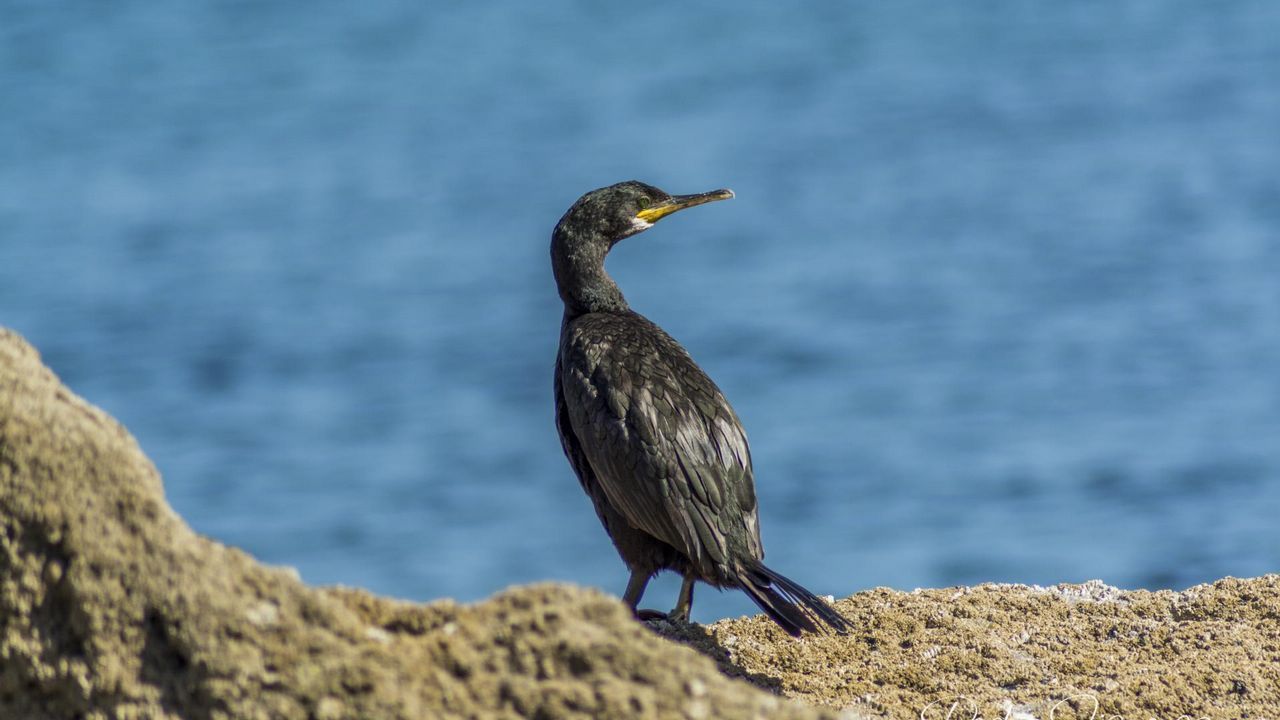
[559,315,763,569]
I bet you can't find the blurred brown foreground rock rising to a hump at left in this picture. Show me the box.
[0,329,835,720]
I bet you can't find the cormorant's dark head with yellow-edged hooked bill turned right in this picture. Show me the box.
[556,181,733,250]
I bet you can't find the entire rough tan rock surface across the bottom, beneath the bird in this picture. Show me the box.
[0,329,1280,720]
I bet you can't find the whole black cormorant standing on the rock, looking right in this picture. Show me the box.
[552,181,850,635]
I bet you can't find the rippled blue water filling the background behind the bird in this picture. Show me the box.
[0,0,1280,620]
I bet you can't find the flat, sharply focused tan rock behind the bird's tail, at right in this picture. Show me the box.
[663,563,1280,720]
